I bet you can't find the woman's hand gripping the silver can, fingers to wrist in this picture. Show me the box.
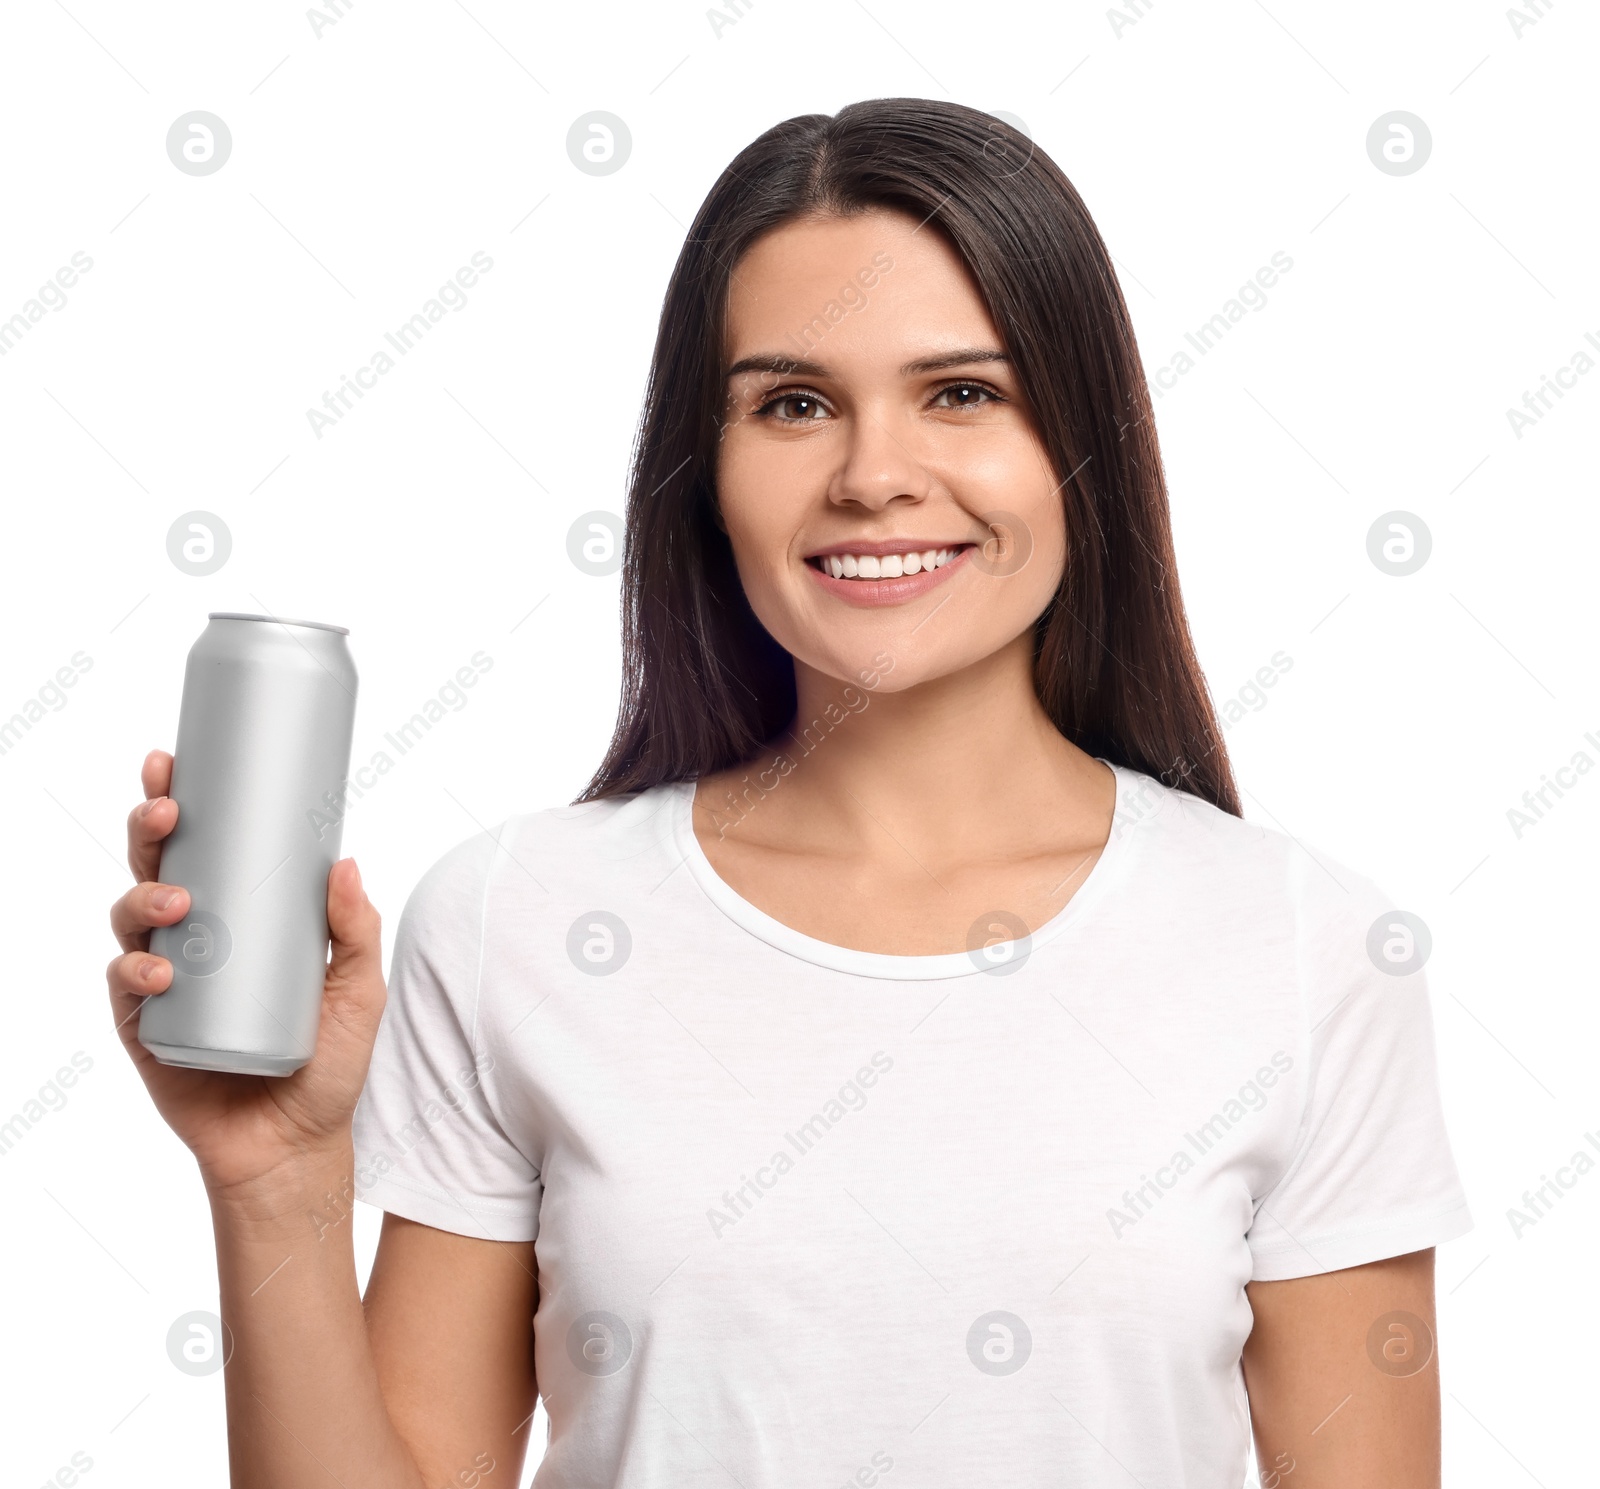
[106,750,384,1196]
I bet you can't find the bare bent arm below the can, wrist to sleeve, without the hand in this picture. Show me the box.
[211,1148,536,1489]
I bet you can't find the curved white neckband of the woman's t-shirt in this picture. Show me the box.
[670,756,1144,982]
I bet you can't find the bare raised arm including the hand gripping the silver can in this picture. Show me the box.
[106,750,534,1489]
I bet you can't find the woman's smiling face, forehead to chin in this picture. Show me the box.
[717,211,1066,691]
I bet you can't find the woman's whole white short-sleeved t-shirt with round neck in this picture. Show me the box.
[355,768,1472,1489]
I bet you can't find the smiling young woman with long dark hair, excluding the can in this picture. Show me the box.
[109,99,1470,1489]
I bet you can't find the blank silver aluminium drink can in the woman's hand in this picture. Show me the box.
[139,611,357,1075]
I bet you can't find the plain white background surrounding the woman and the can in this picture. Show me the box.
[0,0,1600,1489]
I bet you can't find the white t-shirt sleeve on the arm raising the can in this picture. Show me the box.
[354,833,542,1241]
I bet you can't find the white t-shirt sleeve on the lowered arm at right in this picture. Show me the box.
[1245,854,1472,1281]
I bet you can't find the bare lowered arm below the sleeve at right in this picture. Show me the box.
[1245,1251,1440,1489]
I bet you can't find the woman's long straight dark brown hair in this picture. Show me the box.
[579,98,1240,816]
